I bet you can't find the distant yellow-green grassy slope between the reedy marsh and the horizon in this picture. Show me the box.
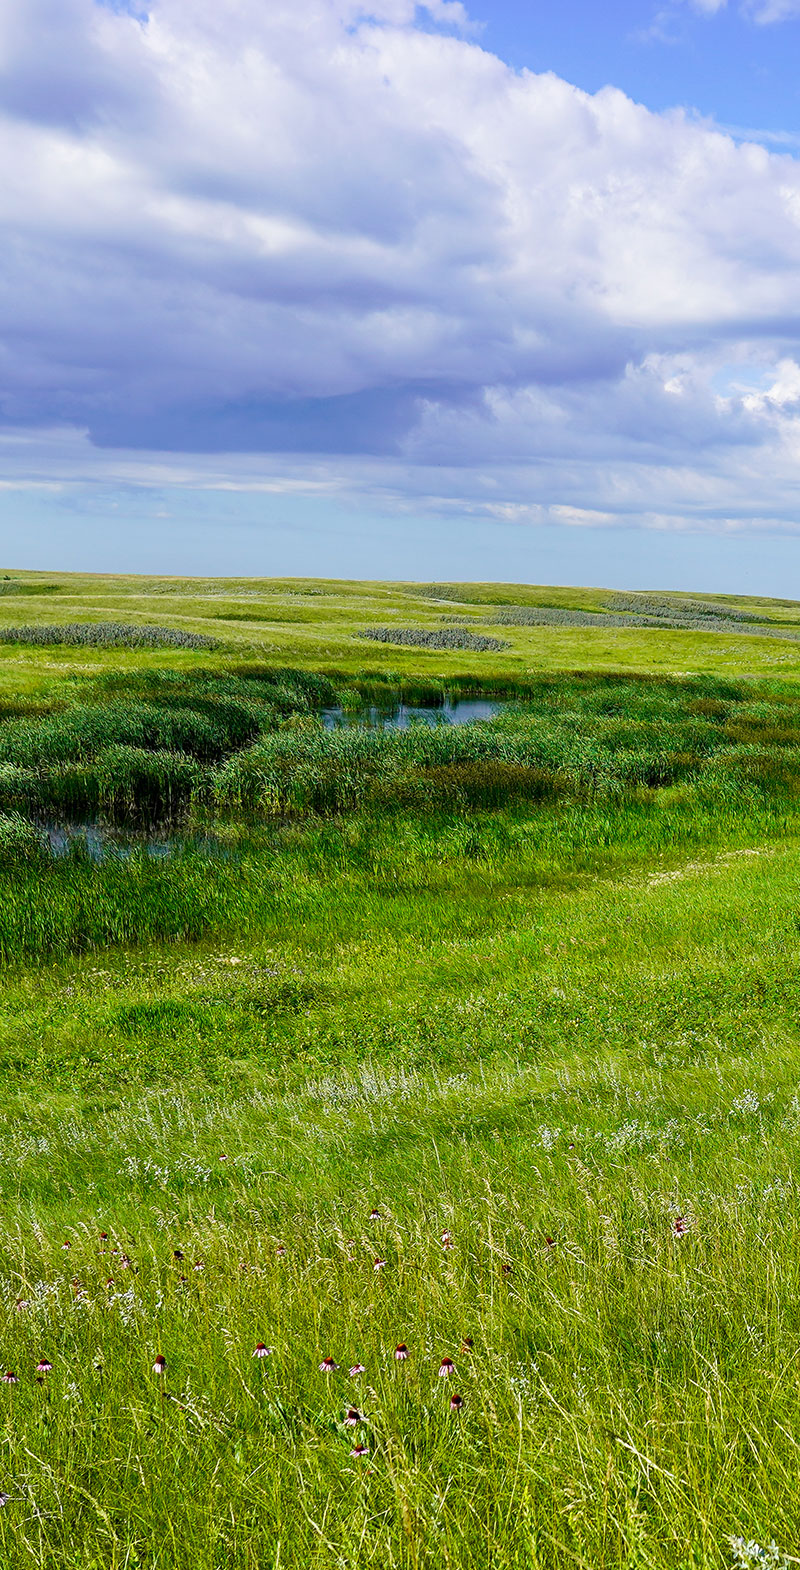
[0,573,800,696]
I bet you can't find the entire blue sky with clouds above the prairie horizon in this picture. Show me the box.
[0,0,800,598]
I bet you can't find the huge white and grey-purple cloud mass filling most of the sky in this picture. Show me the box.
[0,0,800,526]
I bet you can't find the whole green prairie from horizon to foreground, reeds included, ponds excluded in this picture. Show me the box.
[0,573,800,1570]
